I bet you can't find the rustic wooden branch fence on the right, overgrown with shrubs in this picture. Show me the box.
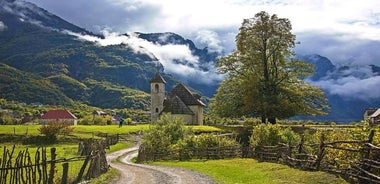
[253,131,380,183]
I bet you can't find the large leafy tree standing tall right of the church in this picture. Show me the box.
[210,12,328,124]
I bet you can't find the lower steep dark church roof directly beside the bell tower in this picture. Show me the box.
[161,93,194,115]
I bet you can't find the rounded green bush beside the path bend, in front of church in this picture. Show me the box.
[138,115,239,161]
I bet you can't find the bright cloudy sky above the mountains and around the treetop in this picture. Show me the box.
[18,0,380,98]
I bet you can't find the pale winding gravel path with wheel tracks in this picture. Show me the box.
[107,146,214,184]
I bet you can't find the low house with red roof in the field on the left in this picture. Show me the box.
[40,110,78,125]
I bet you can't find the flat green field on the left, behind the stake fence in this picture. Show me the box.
[0,125,149,181]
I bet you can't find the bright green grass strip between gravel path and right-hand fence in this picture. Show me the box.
[153,159,347,184]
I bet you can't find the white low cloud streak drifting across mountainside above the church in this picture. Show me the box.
[65,30,222,84]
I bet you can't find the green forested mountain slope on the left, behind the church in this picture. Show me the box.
[0,0,216,109]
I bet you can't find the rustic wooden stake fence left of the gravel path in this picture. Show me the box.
[0,136,119,184]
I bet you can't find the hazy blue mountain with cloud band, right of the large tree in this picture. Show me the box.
[296,54,380,123]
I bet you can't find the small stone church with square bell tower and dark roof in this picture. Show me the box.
[150,72,205,125]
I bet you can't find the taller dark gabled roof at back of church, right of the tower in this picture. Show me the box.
[170,83,205,106]
